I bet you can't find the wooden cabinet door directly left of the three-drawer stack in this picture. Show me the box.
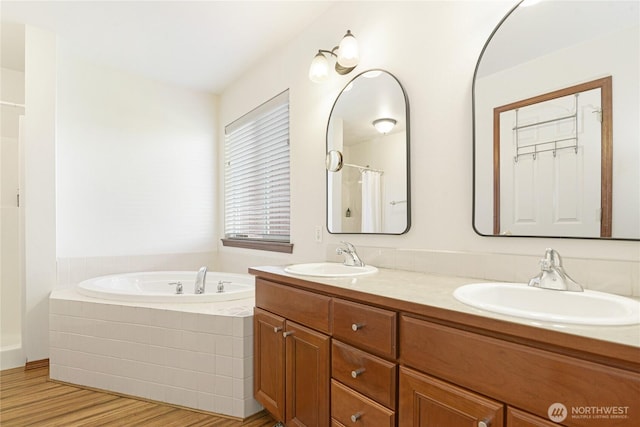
[285,321,330,427]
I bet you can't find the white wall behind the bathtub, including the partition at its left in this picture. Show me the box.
[18,37,217,360]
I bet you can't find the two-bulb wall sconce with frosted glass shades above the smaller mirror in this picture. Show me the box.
[309,30,360,83]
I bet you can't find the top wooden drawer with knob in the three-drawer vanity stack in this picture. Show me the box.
[333,298,398,359]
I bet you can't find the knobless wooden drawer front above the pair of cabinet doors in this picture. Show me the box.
[256,278,331,334]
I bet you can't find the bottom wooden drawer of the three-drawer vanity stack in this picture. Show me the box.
[331,380,396,427]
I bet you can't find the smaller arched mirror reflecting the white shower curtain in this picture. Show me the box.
[326,70,411,234]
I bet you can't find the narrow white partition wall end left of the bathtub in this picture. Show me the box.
[22,26,57,360]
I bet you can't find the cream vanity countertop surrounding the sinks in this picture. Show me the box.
[254,266,640,348]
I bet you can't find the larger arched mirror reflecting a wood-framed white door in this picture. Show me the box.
[473,0,640,240]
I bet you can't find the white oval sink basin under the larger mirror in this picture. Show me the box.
[453,283,640,325]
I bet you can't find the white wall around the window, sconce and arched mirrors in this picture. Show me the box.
[218,1,640,281]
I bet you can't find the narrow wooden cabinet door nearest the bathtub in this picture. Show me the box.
[253,308,285,421]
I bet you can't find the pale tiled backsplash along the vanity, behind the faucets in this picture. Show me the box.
[326,244,640,297]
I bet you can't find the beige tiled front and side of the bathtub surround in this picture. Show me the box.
[49,289,262,418]
